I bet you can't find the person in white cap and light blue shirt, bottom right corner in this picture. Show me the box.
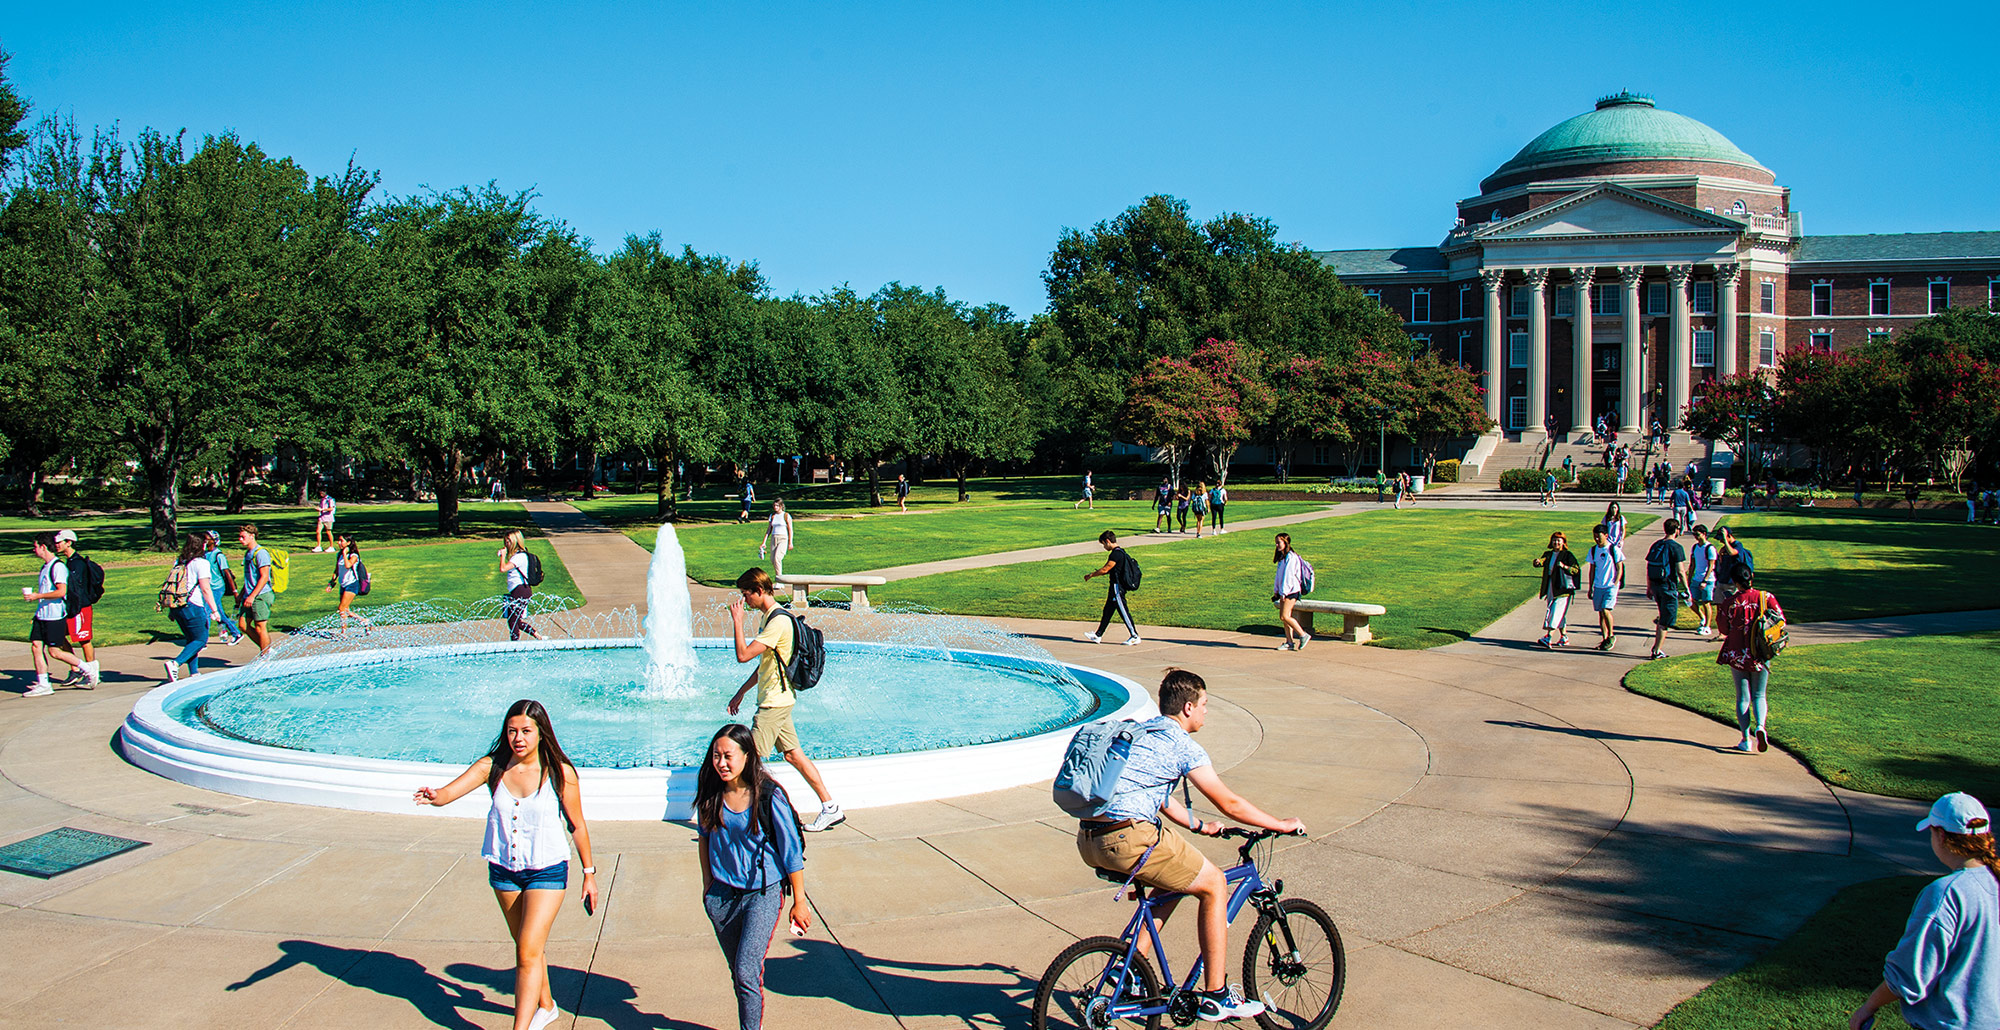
[1848,794,2000,1030]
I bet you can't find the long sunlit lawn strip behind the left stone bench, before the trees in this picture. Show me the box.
[626,500,1326,586]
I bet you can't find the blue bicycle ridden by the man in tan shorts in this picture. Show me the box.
[1034,826,1348,1030]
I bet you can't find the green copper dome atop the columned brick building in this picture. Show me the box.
[1482,92,1774,188]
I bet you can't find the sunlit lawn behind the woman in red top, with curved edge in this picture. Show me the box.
[1626,632,2000,802]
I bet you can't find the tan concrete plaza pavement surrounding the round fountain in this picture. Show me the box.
[0,506,1976,1030]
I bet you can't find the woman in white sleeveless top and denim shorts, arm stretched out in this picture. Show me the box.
[416,698,598,1030]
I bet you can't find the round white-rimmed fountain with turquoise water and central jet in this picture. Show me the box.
[120,526,1152,820]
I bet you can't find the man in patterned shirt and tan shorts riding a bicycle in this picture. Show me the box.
[1076,668,1306,1022]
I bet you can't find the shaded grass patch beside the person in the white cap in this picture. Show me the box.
[1658,876,1932,1030]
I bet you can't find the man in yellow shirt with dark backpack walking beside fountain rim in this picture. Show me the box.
[730,568,848,832]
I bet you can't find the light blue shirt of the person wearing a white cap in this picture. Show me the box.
[1882,866,2000,1030]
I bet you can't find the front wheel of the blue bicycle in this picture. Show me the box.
[1244,898,1348,1030]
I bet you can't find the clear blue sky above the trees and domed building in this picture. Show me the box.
[0,2,2000,316]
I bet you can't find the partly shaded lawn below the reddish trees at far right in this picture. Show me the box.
[1728,512,2000,622]
